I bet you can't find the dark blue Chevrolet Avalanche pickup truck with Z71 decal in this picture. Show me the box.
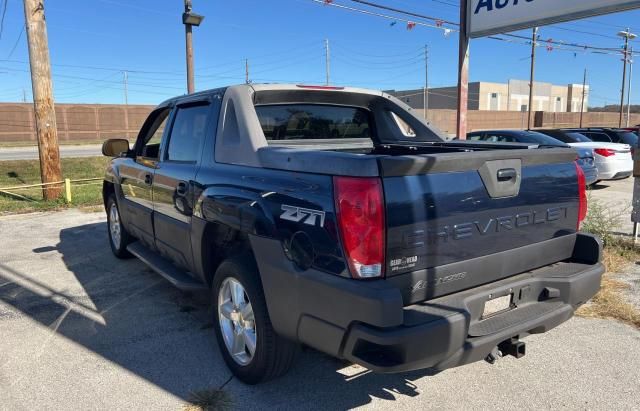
[103,85,604,383]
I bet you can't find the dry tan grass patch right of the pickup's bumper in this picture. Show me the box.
[576,239,640,328]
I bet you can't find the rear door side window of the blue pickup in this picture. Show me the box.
[165,104,209,162]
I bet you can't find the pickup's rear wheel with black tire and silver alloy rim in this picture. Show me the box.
[211,254,299,384]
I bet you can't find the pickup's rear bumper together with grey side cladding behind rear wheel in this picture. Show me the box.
[251,235,604,372]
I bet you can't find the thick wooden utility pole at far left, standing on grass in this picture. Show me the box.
[24,0,62,200]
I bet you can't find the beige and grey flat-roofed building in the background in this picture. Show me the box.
[387,80,589,113]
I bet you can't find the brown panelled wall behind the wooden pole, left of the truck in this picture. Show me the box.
[0,103,153,144]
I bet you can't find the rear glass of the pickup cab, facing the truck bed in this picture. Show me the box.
[256,104,372,141]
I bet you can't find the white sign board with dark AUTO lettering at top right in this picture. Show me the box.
[467,0,640,37]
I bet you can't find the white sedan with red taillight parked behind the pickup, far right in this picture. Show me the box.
[536,130,633,180]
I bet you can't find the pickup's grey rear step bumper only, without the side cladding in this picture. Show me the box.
[343,264,603,372]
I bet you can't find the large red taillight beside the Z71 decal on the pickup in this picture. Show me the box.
[333,177,385,278]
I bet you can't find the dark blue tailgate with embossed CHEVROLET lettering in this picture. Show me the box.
[380,149,579,304]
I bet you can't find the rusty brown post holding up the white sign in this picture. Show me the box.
[456,0,469,140]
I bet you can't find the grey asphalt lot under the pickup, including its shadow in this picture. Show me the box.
[0,209,640,411]
